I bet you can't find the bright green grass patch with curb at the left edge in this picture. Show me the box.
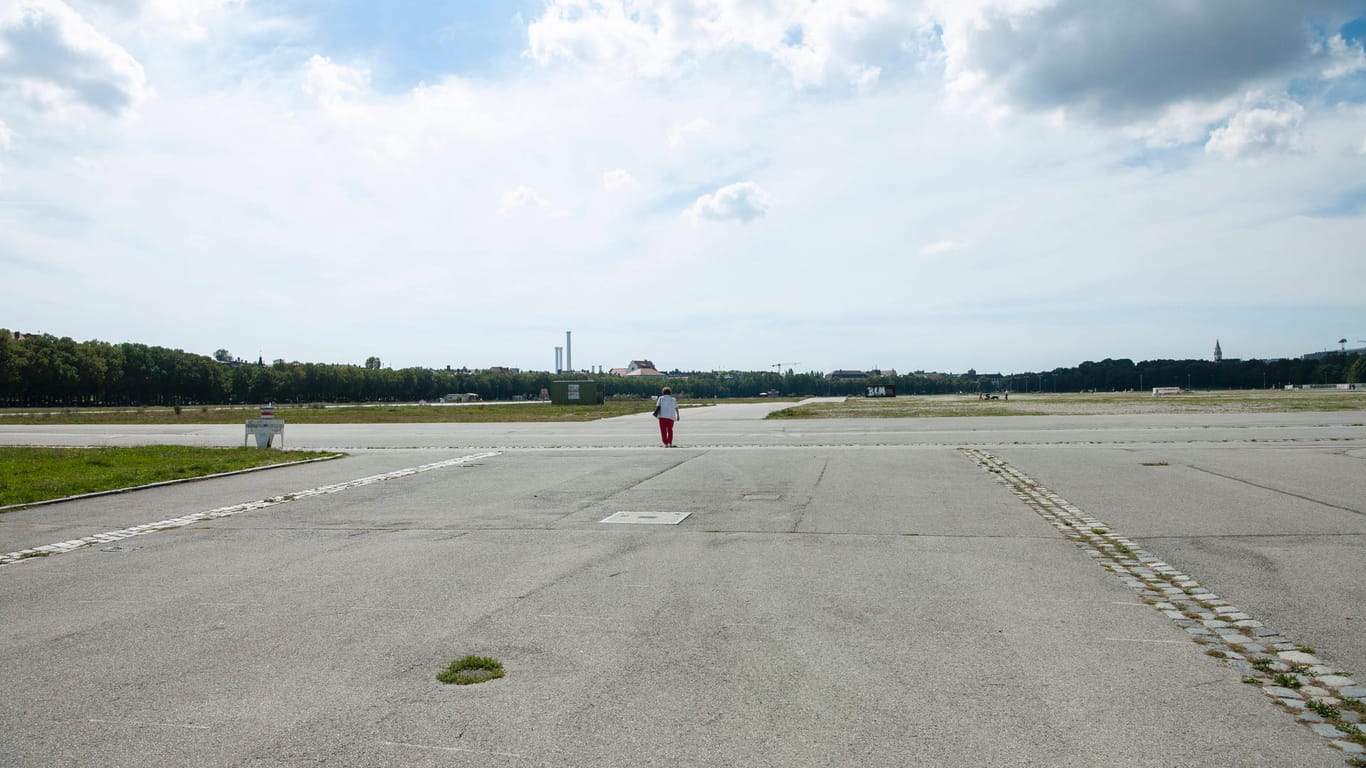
[0,445,336,507]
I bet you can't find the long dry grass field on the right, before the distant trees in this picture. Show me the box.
[768,389,1366,418]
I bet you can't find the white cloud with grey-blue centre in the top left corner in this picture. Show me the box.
[0,0,150,120]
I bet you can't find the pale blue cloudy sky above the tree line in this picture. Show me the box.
[0,0,1366,373]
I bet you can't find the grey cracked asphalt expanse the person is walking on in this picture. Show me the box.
[0,404,1366,767]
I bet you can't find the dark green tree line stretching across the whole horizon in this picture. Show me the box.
[0,328,1366,407]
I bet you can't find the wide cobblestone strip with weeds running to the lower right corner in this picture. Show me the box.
[960,448,1366,765]
